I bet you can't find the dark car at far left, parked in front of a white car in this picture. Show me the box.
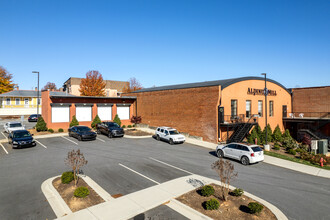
[8,130,36,148]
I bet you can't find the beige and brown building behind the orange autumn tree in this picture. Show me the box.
[63,77,129,97]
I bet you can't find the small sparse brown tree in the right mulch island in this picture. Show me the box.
[211,158,237,201]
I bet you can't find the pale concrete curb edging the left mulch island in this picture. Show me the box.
[41,175,114,218]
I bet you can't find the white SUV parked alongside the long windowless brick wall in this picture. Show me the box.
[156,127,186,145]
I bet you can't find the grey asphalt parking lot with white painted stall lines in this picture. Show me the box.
[0,132,330,219]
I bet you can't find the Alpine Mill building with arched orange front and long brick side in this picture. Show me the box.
[124,77,291,142]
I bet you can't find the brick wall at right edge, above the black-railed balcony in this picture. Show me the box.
[292,86,330,112]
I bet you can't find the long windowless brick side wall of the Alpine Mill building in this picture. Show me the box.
[127,86,220,142]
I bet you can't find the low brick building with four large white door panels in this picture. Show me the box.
[41,91,136,129]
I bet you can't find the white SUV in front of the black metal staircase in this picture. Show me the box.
[216,143,264,165]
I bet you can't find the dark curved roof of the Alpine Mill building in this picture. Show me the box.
[132,76,288,93]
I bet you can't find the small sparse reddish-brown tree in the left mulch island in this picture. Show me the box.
[65,149,88,186]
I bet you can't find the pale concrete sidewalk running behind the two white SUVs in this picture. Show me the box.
[138,128,330,178]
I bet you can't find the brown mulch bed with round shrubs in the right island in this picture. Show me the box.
[176,184,276,220]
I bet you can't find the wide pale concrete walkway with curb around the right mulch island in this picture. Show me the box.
[52,175,287,220]
